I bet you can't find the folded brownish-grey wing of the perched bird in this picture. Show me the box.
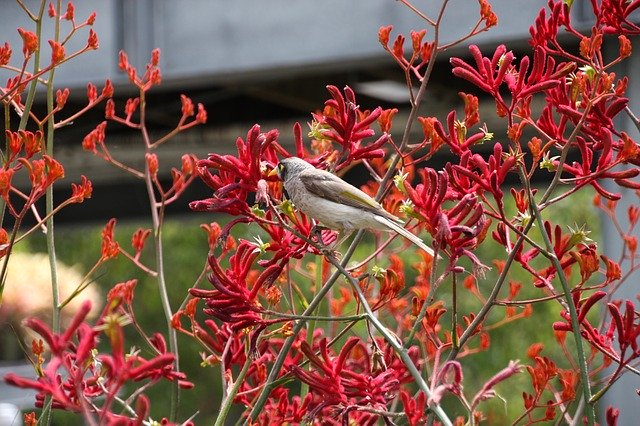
[299,170,399,222]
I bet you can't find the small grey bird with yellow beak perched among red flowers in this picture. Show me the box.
[269,157,433,256]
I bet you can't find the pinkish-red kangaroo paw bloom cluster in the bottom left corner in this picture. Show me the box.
[5,292,192,425]
